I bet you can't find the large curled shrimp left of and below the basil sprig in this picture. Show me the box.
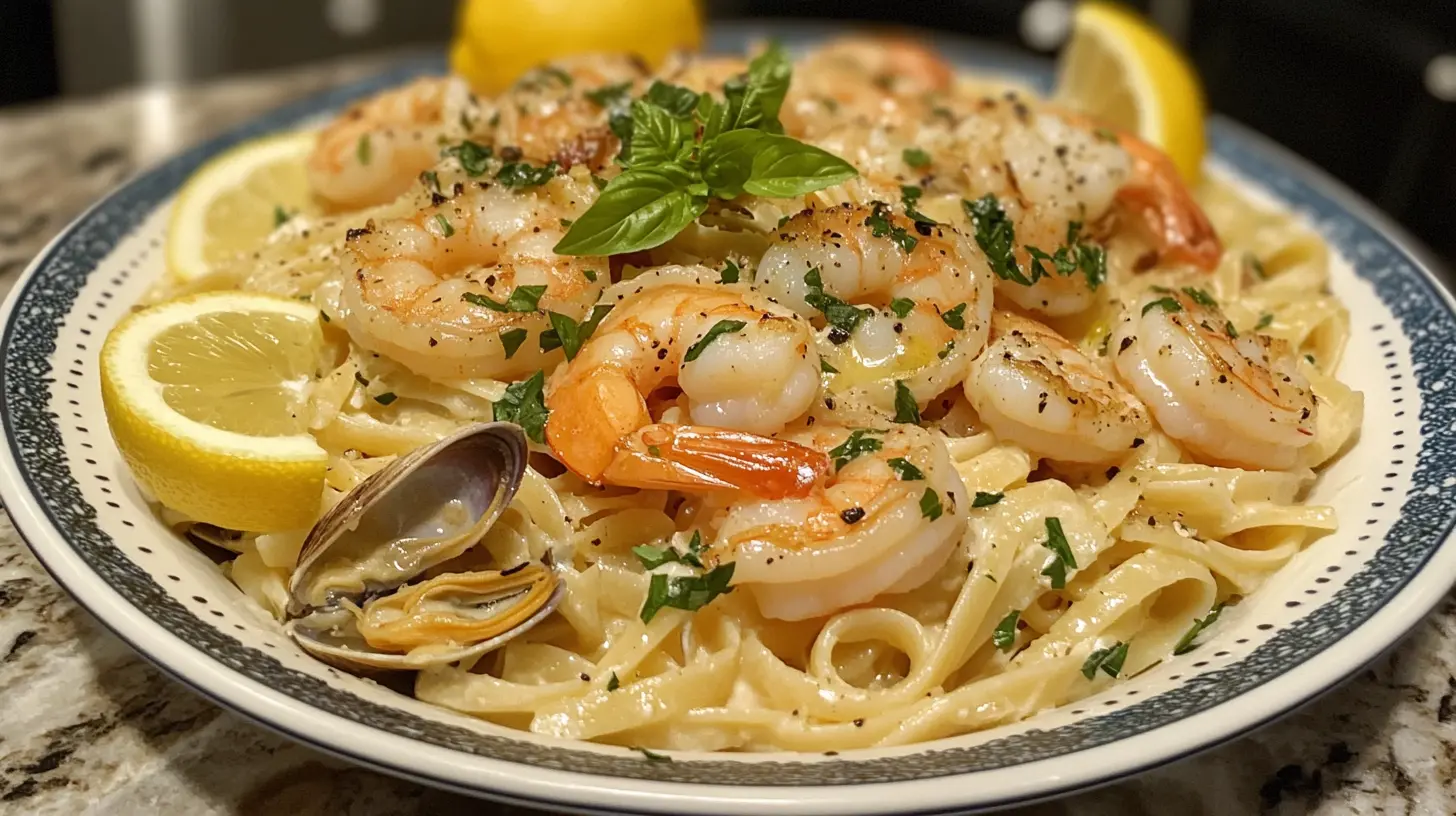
[339,176,607,379]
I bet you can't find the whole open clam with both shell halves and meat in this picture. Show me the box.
[287,423,565,672]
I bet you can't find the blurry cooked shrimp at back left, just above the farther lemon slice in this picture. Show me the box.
[306,77,470,210]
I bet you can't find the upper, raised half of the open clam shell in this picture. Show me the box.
[288,423,529,618]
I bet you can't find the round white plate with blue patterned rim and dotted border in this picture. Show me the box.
[0,29,1456,816]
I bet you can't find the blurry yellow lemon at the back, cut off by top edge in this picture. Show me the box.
[450,0,703,93]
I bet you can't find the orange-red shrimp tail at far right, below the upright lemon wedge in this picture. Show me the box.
[1117,133,1223,270]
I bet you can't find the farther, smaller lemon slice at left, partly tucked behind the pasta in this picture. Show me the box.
[167,131,319,280]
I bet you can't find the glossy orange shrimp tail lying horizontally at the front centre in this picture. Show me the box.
[603,424,828,500]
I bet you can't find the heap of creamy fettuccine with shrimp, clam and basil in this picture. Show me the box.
[131,36,1361,752]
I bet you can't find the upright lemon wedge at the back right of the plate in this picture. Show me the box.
[1054,1,1206,184]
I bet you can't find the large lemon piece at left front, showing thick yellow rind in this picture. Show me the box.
[100,291,326,532]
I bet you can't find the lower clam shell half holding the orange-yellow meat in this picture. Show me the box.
[287,564,565,672]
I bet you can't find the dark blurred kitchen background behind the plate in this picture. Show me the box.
[0,0,1456,261]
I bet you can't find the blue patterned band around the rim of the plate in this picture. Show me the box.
[0,23,1456,810]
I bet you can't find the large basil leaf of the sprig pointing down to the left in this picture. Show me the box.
[555,165,708,255]
